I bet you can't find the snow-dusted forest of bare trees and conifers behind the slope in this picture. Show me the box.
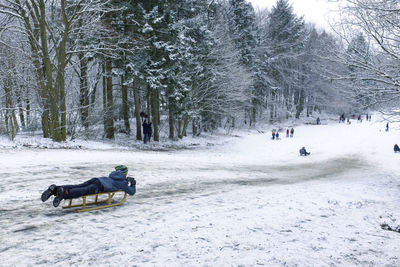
[0,0,400,141]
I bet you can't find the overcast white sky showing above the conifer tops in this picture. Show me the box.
[248,0,338,30]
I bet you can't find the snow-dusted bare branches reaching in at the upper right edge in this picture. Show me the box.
[339,0,400,114]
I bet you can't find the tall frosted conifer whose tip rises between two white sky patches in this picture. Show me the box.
[267,0,307,120]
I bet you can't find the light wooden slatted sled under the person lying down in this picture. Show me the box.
[63,190,127,212]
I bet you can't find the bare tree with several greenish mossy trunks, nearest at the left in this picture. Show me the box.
[0,0,115,141]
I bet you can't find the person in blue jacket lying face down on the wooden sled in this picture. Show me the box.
[42,165,136,207]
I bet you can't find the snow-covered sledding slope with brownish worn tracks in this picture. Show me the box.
[0,118,400,266]
